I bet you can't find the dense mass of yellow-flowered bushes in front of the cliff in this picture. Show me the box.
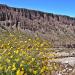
[0,32,58,75]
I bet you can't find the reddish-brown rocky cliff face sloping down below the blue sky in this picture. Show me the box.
[0,4,75,47]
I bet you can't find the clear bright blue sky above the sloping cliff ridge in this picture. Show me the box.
[0,0,75,17]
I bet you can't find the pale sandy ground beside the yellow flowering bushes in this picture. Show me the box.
[48,50,75,75]
